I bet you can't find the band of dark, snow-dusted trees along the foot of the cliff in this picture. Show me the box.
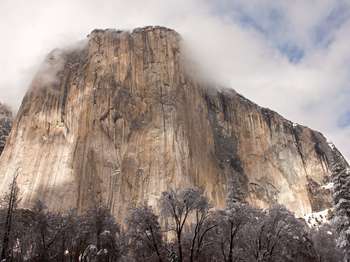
[0,174,344,262]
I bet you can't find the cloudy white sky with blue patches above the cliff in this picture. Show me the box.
[0,0,350,160]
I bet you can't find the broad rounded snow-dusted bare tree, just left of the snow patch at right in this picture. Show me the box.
[250,205,316,262]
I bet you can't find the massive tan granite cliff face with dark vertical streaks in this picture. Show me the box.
[0,27,342,218]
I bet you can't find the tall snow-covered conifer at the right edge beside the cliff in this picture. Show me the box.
[331,147,350,262]
